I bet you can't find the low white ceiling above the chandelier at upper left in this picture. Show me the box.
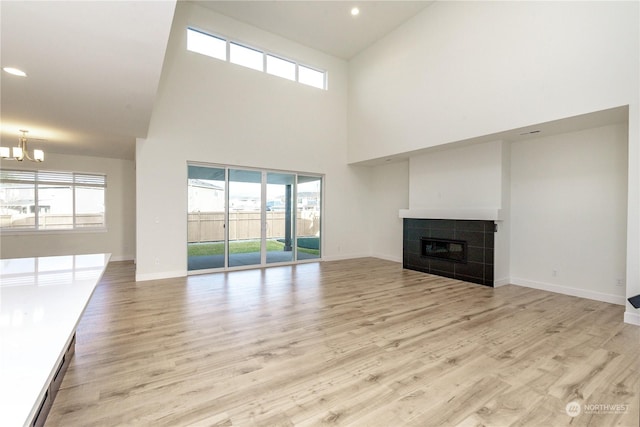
[0,1,175,163]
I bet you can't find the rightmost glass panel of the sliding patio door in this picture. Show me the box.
[296,175,322,260]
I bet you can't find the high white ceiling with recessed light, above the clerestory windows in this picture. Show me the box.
[194,0,433,60]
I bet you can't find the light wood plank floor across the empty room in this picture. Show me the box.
[47,258,640,427]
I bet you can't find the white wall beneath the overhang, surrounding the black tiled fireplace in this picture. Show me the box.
[371,123,628,304]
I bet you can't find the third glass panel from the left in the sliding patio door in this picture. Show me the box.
[266,172,295,263]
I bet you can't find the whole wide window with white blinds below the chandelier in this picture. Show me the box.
[0,169,107,231]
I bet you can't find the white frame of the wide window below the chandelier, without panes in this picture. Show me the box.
[0,168,107,235]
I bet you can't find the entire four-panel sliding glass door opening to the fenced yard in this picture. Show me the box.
[187,164,322,272]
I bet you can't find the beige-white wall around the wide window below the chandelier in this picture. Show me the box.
[0,153,136,261]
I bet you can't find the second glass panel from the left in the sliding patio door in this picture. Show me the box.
[228,169,263,267]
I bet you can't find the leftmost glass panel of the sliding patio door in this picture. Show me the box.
[187,165,226,271]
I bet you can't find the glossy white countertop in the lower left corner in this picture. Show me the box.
[0,254,111,427]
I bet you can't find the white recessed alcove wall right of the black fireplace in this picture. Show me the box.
[511,123,628,304]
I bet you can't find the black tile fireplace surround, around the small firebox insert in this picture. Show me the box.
[402,218,495,287]
